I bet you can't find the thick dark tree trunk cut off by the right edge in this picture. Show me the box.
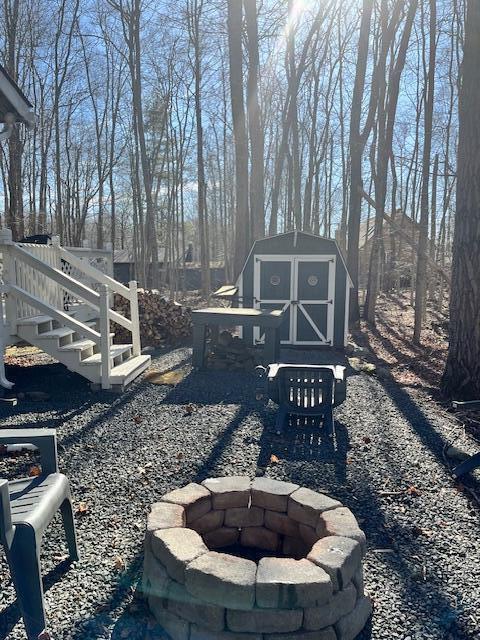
[442,0,480,400]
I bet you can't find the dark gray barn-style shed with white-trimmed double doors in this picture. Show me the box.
[237,231,352,348]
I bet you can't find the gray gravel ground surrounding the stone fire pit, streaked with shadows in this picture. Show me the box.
[0,349,480,640]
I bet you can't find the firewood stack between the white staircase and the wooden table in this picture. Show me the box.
[113,289,192,347]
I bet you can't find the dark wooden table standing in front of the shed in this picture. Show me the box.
[192,307,283,368]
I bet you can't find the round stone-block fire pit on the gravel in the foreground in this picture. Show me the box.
[143,476,371,640]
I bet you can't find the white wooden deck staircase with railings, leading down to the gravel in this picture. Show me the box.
[0,229,150,389]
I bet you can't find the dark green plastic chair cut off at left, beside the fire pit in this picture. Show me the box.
[0,429,78,640]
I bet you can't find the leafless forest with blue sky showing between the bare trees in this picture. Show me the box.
[0,0,480,395]
